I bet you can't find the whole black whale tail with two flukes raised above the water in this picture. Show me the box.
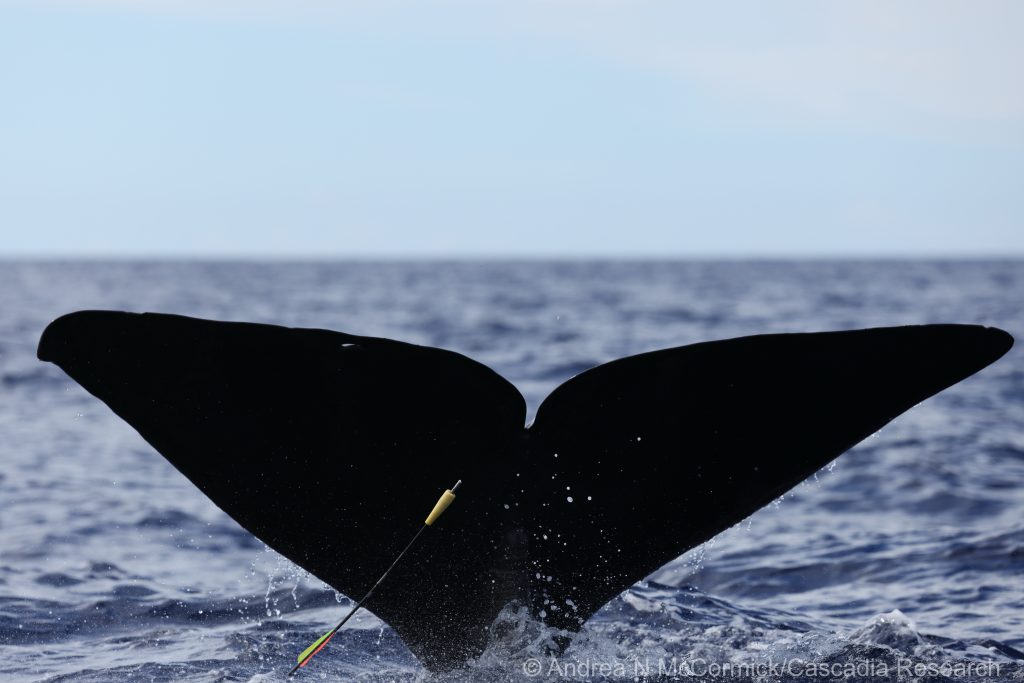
[38,311,1013,671]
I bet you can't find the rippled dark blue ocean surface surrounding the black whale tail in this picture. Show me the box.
[0,261,1024,683]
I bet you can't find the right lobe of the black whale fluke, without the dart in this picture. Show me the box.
[520,325,1013,628]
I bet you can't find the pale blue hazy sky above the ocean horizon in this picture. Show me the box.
[0,0,1024,258]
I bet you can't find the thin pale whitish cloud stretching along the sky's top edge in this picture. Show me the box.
[16,0,1024,124]
